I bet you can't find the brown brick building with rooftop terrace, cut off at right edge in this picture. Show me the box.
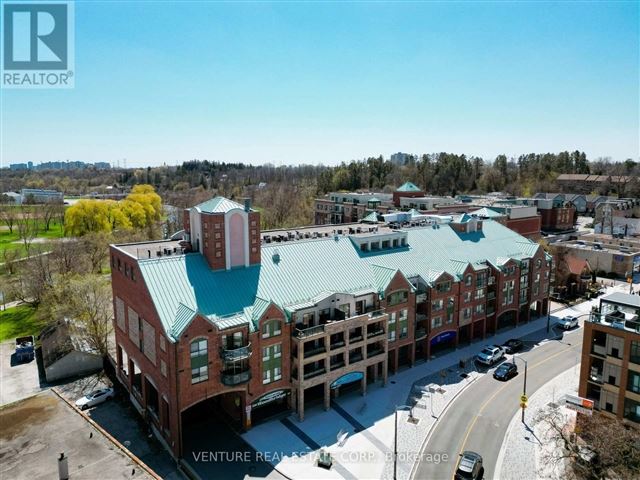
[578,292,640,424]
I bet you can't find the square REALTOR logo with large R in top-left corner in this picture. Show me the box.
[2,1,74,88]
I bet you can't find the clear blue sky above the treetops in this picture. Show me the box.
[1,1,640,166]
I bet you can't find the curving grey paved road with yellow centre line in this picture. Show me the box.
[414,328,582,480]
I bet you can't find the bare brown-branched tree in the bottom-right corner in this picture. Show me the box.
[535,407,640,480]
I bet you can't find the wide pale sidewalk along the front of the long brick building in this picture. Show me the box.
[243,305,576,479]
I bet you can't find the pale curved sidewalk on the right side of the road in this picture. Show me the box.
[495,364,580,480]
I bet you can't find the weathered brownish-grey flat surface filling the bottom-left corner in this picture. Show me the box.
[0,390,153,480]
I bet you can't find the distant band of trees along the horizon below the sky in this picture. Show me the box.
[0,150,640,230]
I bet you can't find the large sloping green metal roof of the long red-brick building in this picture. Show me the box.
[138,221,541,339]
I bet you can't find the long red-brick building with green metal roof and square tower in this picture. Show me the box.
[110,197,551,457]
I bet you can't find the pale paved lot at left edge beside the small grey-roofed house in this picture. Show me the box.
[0,341,43,405]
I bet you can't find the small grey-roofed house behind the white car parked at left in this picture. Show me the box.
[40,320,103,382]
